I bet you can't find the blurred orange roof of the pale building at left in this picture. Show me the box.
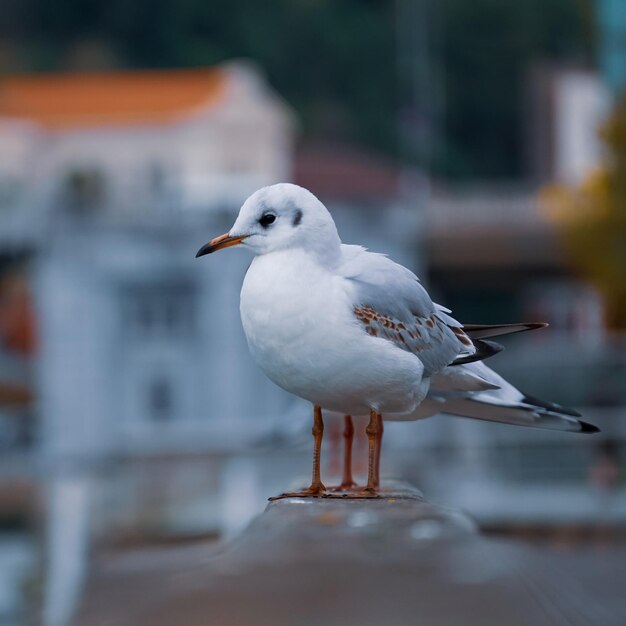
[0,68,226,129]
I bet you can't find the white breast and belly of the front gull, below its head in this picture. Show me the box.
[236,250,428,414]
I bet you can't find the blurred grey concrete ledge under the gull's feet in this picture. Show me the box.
[76,484,624,626]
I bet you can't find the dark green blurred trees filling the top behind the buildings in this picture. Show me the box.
[0,0,593,178]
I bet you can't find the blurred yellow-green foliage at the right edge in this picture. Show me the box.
[544,97,626,331]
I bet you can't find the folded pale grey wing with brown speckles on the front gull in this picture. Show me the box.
[341,245,475,376]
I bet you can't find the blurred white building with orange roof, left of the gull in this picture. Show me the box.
[0,63,294,457]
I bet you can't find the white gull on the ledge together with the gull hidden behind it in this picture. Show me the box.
[196,183,598,497]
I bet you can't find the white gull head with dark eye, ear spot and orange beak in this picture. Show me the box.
[196,183,341,260]
